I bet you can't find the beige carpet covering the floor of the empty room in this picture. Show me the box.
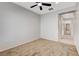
[0,39,78,56]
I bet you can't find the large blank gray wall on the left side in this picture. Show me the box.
[0,2,40,51]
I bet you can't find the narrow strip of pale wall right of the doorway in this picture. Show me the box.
[74,3,79,53]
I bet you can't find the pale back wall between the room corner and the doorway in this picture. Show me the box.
[40,13,58,41]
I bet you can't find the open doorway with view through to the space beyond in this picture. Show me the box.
[58,11,75,44]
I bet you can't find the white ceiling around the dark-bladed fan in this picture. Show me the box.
[14,2,76,15]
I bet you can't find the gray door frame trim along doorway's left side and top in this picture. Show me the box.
[58,10,76,40]
